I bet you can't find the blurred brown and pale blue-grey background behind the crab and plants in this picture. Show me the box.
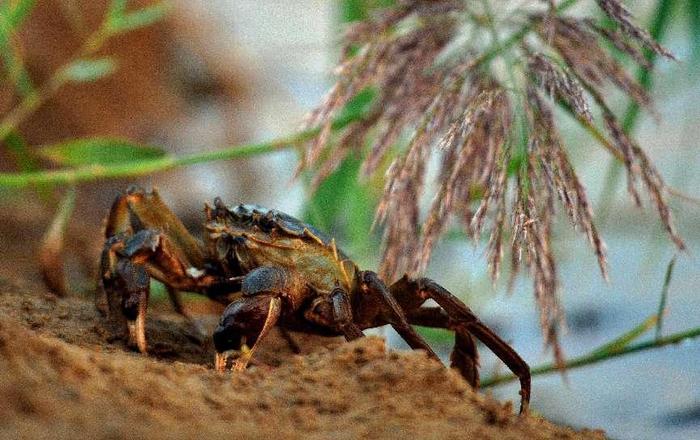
[0,0,700,439]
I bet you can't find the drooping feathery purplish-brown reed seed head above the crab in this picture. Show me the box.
[305,0,684,365]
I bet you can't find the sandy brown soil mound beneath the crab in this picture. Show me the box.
[0,279,604,439]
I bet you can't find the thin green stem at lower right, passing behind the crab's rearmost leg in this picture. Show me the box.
[481,327,700,388]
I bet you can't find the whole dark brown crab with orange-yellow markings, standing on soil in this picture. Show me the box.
[99,187,530,413]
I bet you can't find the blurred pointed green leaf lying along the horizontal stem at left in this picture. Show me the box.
[37,138,165,167]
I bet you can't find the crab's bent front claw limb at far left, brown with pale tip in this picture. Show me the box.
[98,187,227,353]
